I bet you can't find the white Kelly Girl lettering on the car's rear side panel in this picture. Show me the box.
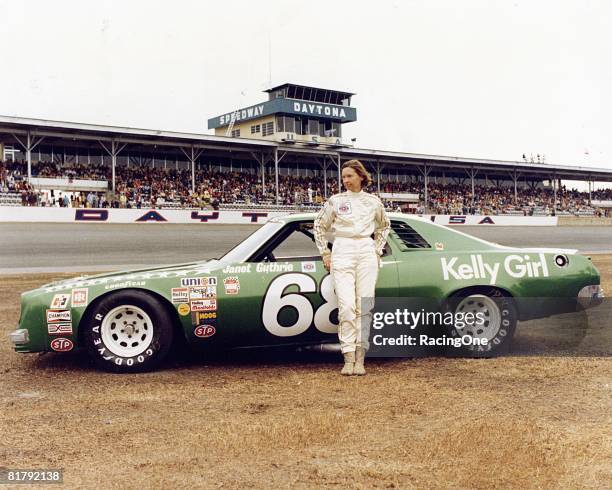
[440,253,548,285]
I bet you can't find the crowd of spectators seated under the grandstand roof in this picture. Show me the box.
[0,162,612,215]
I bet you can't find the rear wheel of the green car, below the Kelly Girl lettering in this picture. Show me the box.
[445,288,518,357]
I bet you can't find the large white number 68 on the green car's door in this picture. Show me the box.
[262,273,338,337]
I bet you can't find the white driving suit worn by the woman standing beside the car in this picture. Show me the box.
[314,191,390,353]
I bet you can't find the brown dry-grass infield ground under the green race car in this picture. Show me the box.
[0,255,612,488]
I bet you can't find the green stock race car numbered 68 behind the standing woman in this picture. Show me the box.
[10,214,602,372]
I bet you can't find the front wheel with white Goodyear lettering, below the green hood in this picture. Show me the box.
[82,289,174,373]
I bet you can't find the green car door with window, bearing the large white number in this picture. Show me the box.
[219,219,398,346]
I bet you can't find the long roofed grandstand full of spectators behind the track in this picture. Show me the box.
[0,110,612,216]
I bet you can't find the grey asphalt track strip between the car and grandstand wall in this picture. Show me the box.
[0,223,612,274]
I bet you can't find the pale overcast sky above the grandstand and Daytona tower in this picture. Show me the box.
[0,0,612,174]
